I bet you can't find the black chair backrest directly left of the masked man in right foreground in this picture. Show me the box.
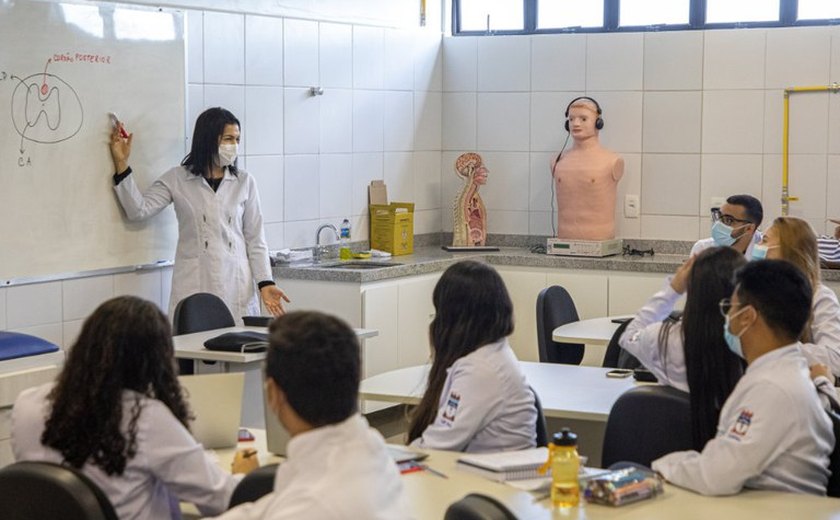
[601,385,694,468]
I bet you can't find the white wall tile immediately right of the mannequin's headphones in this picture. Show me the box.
[594,92,642,153]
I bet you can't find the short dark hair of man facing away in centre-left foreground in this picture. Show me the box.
[265,311,362,427]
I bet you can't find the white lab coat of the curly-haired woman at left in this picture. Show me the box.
[12,383,241,520]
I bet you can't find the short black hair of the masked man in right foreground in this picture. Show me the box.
[735,260,814,343]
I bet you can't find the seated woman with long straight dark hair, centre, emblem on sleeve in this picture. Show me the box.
[408,261,537,452]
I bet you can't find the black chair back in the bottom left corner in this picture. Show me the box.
[0,461,118,520]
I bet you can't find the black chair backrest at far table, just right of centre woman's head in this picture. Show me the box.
[537,285,584,365]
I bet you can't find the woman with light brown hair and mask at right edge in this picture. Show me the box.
[753,213,840,376]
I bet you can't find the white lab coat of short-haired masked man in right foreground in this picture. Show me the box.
[653,343,835,495]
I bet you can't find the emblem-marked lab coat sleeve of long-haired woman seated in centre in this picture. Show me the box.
[411,364,503,451]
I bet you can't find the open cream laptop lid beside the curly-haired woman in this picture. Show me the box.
[178,372,245,449]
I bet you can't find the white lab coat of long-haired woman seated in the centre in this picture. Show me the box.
[411,338,537,452]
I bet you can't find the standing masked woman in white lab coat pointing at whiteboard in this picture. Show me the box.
[110,107,289,323]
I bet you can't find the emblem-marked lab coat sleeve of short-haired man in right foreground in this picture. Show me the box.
[652,385,800,495]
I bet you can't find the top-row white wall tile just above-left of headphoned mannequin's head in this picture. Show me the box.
[531,34,586,92]
